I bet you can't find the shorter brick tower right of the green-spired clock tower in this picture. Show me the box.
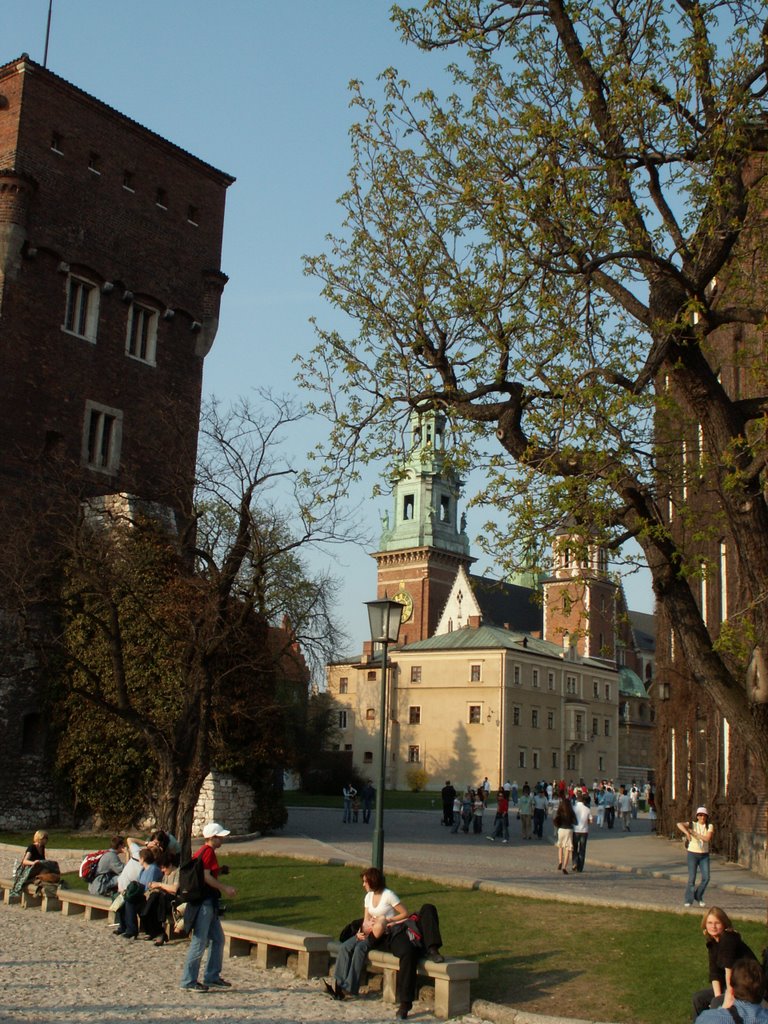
[543,523,616,662]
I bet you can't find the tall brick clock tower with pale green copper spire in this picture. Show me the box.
[373,410,473,644]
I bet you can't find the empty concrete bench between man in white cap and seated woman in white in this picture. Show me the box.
[221,919,331,978]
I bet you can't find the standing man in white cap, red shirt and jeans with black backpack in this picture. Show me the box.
[181,821,237,992]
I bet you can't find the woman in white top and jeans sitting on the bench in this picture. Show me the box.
[325,867,409,999]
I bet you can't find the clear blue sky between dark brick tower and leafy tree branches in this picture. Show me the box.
[0,0,651,649]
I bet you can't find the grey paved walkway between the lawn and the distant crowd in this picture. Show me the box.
[233,808,768,922]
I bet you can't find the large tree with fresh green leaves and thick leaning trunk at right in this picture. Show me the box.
[302,0,768,790]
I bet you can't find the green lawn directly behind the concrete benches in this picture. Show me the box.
[68,848,765,1024]
